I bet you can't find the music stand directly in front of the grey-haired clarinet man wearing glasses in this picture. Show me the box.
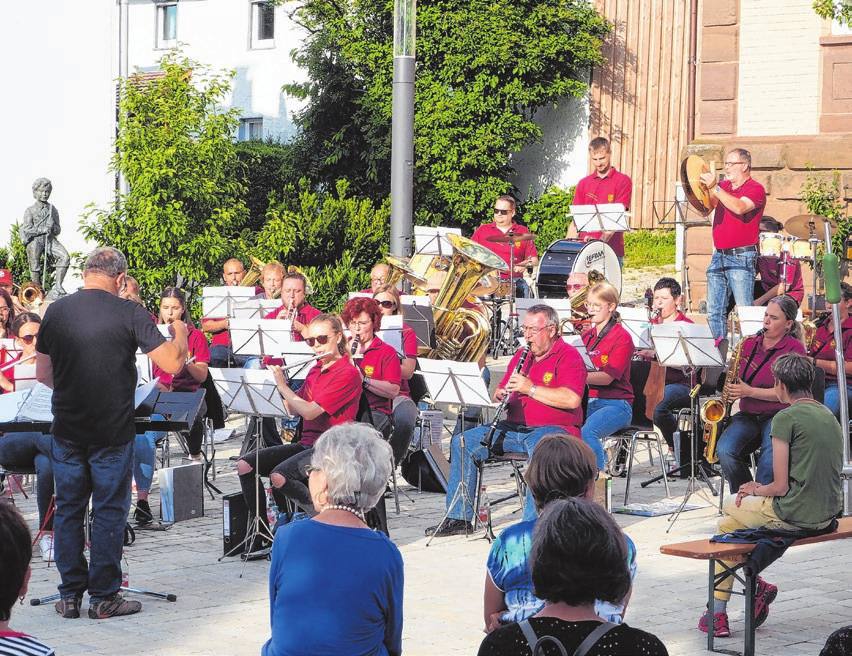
[420,358,494,547]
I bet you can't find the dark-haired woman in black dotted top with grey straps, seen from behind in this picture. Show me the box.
[479,498,668,656]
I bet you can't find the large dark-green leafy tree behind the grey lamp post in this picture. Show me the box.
[285,0,610,229]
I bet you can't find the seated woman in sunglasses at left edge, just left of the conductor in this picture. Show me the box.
[0,312,54,562]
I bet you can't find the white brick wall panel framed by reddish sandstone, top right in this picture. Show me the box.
[737,0,822,136]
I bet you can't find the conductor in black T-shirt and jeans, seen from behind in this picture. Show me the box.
[36,248,187,619]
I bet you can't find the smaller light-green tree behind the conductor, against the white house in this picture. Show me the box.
[82,52,247,300]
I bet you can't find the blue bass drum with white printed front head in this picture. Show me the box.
[535,239,621,298]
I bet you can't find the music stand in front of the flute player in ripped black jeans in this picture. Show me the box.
[210,368,291,578]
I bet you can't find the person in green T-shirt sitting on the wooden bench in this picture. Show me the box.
[698,354,843,638]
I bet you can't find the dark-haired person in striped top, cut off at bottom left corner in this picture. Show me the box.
[0,501,55,656]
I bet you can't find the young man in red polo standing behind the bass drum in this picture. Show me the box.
[565,137,633,268]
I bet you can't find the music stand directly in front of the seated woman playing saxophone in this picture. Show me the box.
[641,321,724,533]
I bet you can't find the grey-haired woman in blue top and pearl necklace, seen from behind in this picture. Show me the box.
[261,423,403,656]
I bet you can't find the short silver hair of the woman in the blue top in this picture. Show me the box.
[311,422,393,510]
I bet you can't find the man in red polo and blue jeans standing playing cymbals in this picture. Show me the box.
[701,148,766,340]
